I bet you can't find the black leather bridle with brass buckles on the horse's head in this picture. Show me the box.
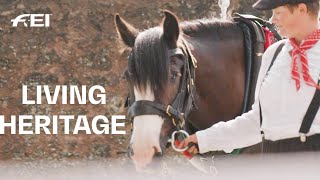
[128,40,197,130]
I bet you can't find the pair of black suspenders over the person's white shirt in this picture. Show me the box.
[259,42,320,142]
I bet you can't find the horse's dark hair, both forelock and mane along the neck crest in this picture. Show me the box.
[129,19,235,95]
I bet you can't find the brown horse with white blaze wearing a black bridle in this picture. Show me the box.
[115,10,262,168]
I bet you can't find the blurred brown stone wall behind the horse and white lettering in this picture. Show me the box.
[0,0,270,161]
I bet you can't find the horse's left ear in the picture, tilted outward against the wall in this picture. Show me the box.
[114,14,139,47]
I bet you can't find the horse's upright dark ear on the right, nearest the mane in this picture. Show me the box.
[163,10,180,46]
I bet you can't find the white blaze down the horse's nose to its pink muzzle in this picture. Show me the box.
[130,85,164,169]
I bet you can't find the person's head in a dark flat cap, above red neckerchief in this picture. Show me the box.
[253,0,319,38]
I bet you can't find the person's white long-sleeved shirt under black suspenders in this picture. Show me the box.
[196,40,320,153]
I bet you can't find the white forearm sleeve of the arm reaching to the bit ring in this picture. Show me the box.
[196,104,262,153]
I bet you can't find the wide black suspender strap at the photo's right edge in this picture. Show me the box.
[299,75,320,134]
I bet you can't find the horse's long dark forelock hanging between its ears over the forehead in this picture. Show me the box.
[133,27,169,95]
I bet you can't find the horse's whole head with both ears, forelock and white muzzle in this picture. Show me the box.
[115,11,190,168]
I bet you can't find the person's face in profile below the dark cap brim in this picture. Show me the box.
[271,6,300,38]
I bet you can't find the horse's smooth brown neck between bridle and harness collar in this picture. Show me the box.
[181,25,244,129]
